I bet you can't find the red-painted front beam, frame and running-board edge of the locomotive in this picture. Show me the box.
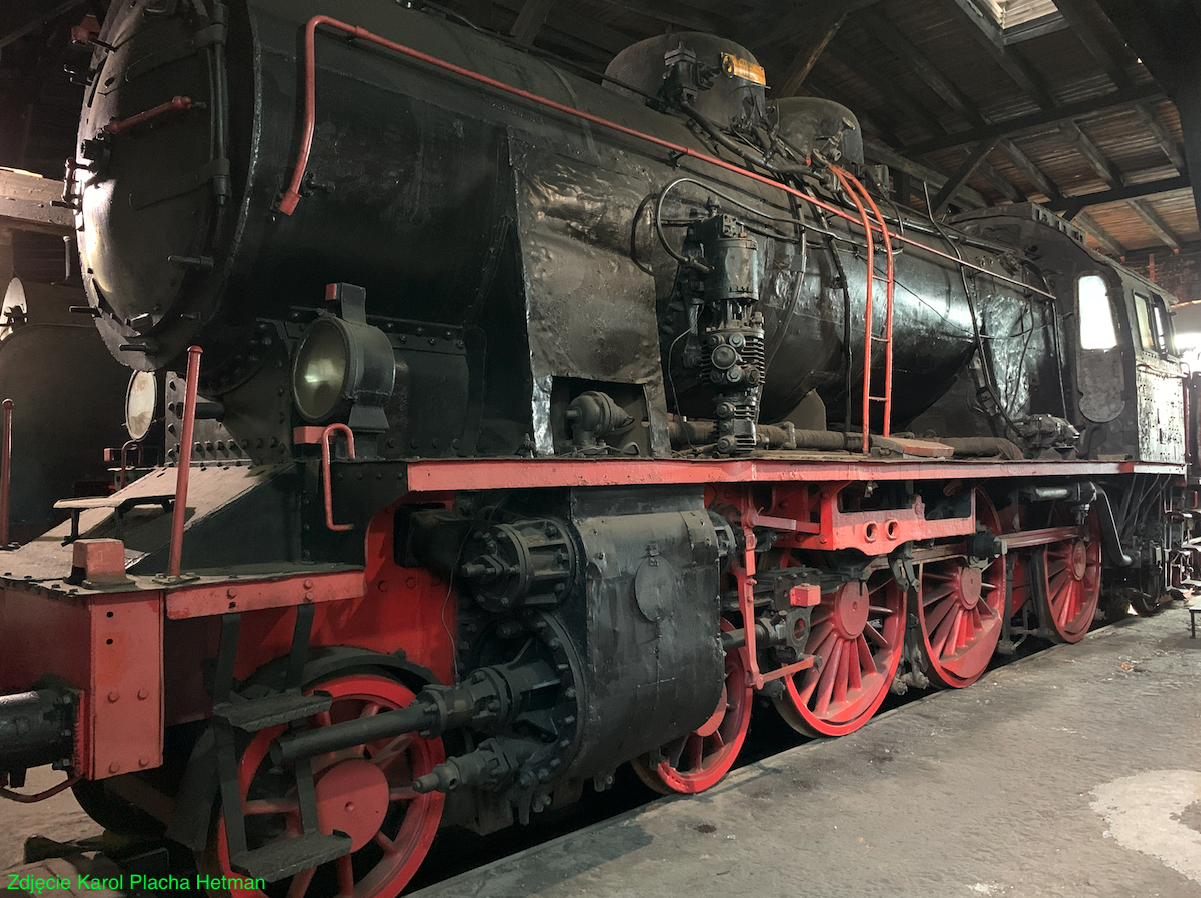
[0,457,1184,779]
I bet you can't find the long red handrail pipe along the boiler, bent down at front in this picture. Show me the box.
[280,16,1056,299]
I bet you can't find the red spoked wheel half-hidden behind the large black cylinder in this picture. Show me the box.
[631,618,753,795]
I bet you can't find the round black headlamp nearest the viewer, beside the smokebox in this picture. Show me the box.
[292,285,396,432]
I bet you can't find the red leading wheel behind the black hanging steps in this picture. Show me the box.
[197,674,446,898]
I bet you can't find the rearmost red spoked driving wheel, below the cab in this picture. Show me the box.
[1035,505,1101,642]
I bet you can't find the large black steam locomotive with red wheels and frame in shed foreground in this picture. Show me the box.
[0,0,1197,898]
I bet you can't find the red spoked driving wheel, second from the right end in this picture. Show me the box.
[913,490,1005,688]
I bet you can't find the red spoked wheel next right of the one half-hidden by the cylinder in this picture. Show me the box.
[772,570,906,736]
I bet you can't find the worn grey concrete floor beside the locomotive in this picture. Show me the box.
[7,605,1201,898]
